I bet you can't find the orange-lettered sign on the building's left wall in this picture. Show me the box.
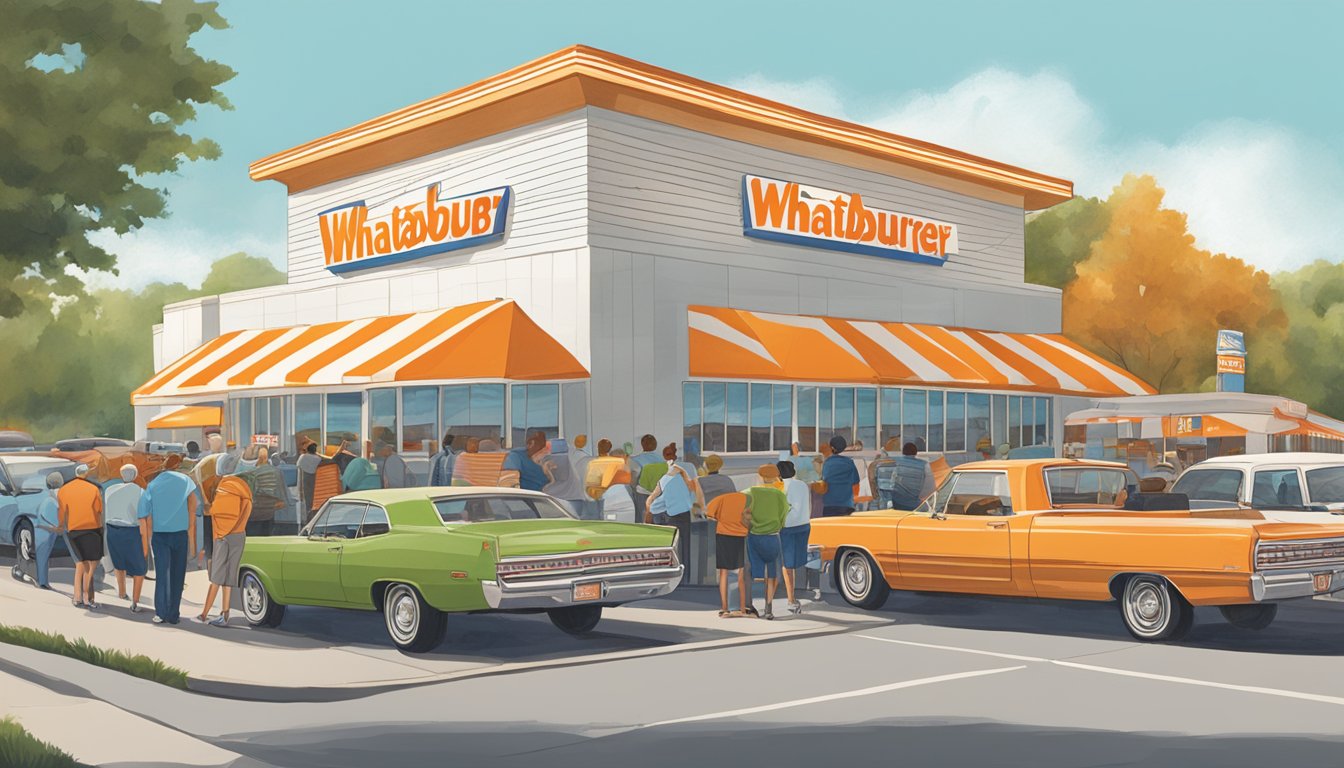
[317,184,512,273]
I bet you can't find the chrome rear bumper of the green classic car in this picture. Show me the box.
[481,565,685,611]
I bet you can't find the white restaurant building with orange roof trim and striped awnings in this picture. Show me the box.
[132,46,1152,463]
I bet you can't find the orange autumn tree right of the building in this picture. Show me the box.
[1063,175,1288,391]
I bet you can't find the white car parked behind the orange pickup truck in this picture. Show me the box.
[1171,453,1344,523]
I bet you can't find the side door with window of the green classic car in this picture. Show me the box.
[282,502,366,603]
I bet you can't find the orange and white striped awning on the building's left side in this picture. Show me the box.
[130,300,589,405]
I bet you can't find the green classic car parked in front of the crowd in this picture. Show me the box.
[239,488,683,652]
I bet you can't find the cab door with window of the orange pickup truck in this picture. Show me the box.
[896,471,1012,593]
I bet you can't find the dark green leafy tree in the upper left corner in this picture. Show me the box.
[0,0,234,317]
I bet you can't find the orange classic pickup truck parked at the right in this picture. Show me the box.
[809,459,1344,640]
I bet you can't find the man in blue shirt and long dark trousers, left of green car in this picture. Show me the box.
[138,453,206,624]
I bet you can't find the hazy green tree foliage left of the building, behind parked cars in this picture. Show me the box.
[0,253,285,441]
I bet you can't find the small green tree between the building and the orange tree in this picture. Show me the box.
[1027,198,1110,288]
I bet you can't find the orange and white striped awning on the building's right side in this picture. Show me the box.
[689,307,1156,397]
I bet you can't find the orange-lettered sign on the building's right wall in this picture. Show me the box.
[742,176,958,265]
